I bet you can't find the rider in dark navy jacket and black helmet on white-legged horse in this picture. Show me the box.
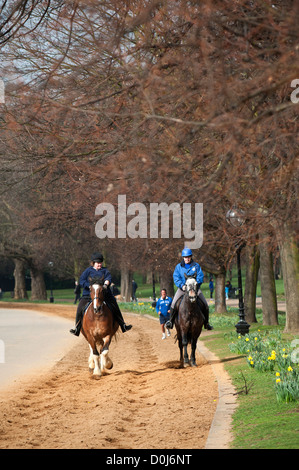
[70,253,132,336]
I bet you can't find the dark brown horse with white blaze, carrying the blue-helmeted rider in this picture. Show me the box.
[175,275,204,367]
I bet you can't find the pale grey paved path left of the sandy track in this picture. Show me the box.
[0,308,73,388]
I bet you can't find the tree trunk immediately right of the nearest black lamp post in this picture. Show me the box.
[244,245,260,323]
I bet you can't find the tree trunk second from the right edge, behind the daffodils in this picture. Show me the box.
[259,242,278,325]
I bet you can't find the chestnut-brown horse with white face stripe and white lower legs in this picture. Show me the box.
[81,277,119,376]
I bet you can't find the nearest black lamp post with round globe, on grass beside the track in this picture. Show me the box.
[226,208,250,335]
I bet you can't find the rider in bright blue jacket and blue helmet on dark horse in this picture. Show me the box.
[165,248,213,330]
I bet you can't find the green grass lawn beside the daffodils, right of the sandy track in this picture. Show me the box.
[202,309,299,449]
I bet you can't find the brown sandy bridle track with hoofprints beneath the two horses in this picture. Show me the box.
[0,304,218,449]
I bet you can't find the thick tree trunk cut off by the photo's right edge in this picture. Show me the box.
[279,222,299,333]
